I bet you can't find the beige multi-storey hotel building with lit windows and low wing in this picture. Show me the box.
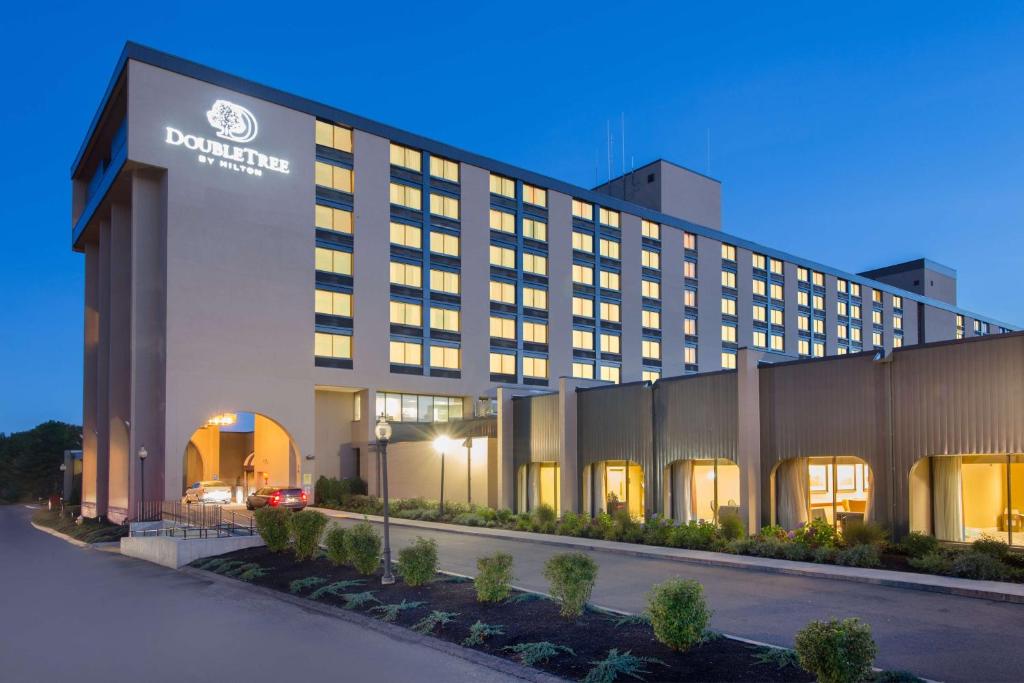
[72,44,1024,542]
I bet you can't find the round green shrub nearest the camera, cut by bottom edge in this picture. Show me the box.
[797,618,878,683]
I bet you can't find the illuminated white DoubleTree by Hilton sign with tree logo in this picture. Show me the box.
[164,99,290,176]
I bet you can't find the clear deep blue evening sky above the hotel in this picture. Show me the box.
[0,0,1024,431]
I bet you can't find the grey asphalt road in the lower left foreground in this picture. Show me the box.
[0,506,520,683]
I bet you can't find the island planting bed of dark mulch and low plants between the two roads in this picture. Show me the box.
[195,548,814,681]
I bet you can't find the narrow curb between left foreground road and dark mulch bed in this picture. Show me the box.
[178,566,563,683]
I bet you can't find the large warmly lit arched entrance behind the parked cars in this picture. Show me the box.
[181,412,301,503]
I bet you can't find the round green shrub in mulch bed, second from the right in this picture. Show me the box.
[647,579,711,651]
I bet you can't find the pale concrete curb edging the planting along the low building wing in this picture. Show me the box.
[315,508,1024,604]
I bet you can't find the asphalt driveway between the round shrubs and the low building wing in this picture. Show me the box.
[329,520,1024,682]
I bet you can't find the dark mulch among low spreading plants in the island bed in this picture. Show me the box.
[195,547,814,681]
